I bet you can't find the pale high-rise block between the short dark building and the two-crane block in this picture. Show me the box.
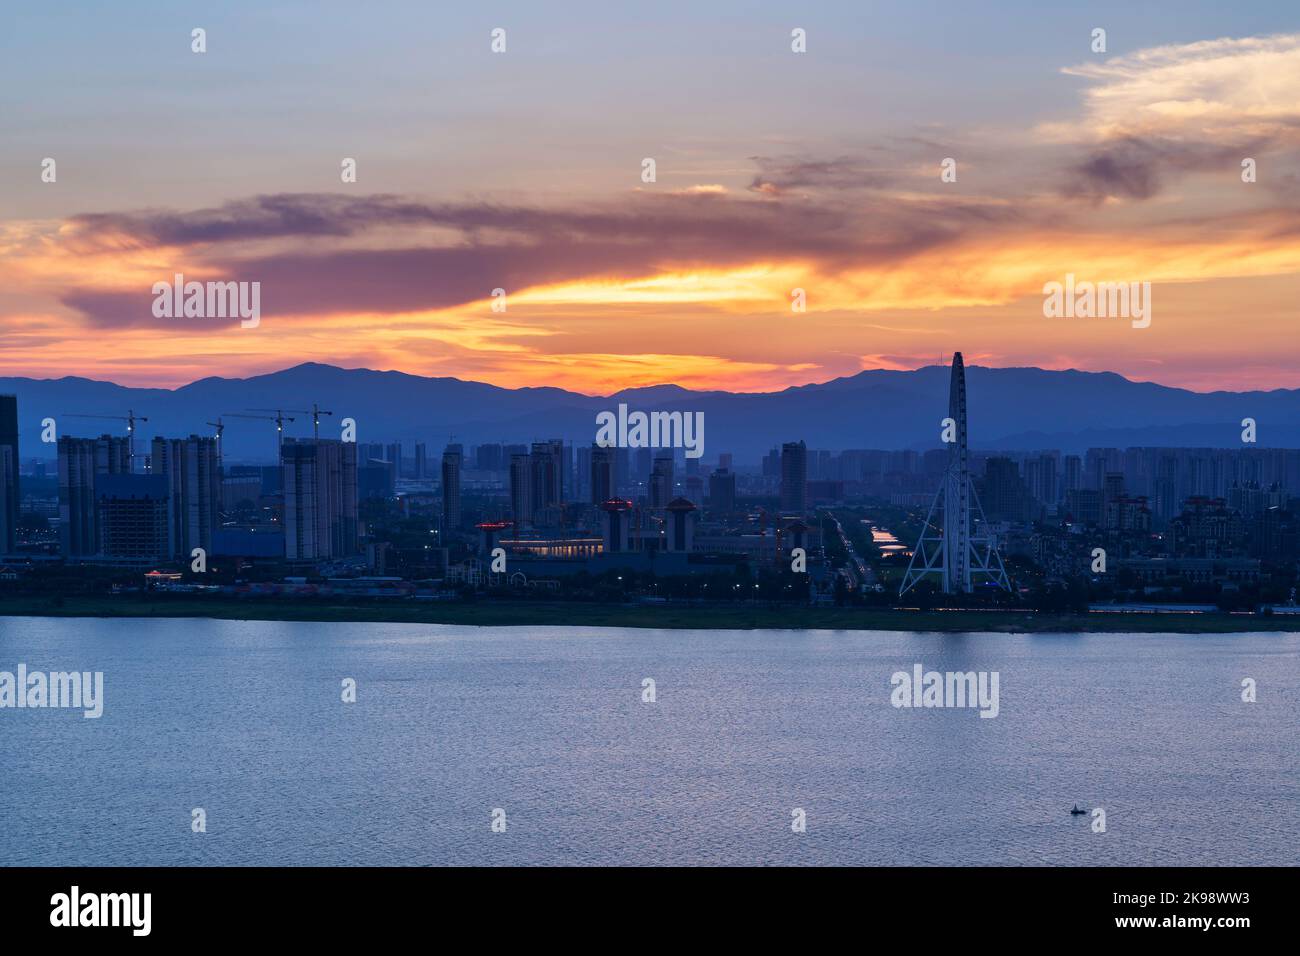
[150,434,221,559]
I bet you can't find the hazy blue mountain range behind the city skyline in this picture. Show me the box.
[0,363,1300,462]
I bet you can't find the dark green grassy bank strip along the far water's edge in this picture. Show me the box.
[0,594,1300,633]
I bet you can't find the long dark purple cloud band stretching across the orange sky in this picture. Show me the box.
[55,174,1040,328]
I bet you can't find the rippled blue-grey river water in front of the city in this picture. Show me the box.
[0,618,1300,865]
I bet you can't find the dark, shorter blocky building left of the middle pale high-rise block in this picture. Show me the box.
[95,476,170,561]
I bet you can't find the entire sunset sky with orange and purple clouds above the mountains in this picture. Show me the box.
[0,0,1300,393]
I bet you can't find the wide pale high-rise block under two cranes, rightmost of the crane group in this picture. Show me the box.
[281,438,358,561]
